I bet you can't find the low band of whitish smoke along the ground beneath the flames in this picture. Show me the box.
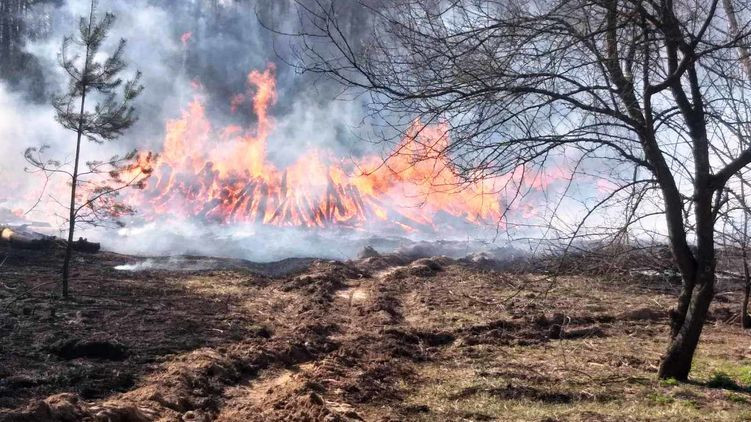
[110,222,526,262]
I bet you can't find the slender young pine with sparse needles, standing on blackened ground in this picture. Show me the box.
[25,0,151,298]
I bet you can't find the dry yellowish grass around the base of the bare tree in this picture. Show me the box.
[400,276,751,421]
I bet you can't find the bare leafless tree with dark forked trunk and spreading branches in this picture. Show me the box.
[278,0,751,380]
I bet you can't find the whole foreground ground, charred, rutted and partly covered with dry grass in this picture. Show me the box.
[0,252,751,422]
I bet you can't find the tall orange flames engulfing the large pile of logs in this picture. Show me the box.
[128,66,548,231]
